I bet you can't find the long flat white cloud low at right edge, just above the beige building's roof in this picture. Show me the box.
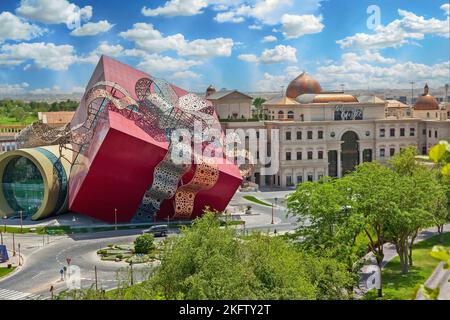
[316,53,450,89]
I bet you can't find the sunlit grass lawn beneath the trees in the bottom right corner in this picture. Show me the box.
[364,233,450,300]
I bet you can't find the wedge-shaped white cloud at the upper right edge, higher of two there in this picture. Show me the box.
[336,10,450,49]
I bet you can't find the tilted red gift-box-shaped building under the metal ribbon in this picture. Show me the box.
[68,56,242,223]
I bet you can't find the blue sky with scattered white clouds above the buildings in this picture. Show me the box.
[0,0,450,96]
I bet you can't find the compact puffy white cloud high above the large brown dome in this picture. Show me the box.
[281,14,325,39]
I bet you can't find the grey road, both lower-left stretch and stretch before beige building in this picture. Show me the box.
[0,191,295,299]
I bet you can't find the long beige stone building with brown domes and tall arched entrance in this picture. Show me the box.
[222,73,450,187]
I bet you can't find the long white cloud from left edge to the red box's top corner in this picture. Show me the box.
[0,42,97,71]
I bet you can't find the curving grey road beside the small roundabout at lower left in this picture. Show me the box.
[0,230,158,297]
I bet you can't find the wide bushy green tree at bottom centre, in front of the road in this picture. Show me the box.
[149,213,351,299]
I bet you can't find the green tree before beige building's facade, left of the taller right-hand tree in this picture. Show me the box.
[287,178,367,272]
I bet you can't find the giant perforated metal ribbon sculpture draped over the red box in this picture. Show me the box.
[17,78,253,222]
